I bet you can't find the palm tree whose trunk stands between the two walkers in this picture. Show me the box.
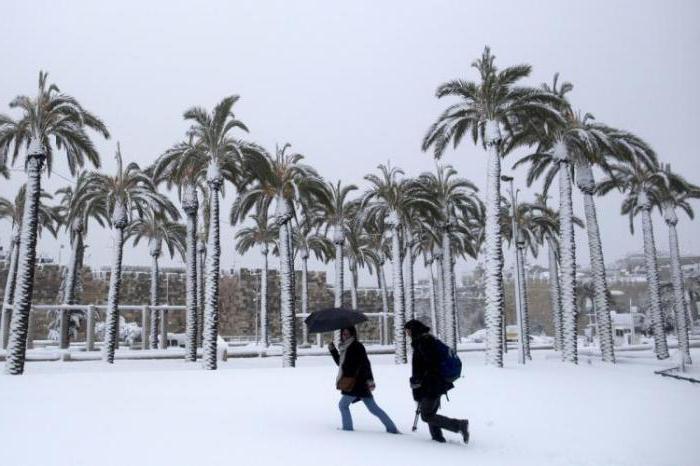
[362,165,430,364]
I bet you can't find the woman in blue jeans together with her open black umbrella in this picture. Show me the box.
[304,308,399,434]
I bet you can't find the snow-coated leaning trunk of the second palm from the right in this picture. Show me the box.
[640,197,669,359]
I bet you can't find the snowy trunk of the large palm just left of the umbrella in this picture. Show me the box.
[279,220,296,367]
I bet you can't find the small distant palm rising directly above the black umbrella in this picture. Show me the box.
[321,181,357,314]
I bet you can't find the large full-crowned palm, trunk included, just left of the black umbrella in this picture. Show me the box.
[231,144,323,367]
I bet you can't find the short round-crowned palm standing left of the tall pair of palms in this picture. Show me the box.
[124,209,187,349]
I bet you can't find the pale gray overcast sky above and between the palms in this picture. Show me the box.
[0,0,700,282]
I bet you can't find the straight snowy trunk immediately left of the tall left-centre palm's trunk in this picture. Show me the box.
[182,184,199,362]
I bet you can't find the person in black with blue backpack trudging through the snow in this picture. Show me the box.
[404,319,469,443]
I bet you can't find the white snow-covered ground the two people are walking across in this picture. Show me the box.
[0,350,700,466]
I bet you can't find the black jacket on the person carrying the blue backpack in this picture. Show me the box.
[411,333,454,401]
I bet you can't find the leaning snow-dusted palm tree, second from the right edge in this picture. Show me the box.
[596,155,669,359]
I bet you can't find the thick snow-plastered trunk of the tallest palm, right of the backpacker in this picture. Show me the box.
[484,138,504,367]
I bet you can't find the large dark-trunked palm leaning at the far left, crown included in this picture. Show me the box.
[0,72,109,375]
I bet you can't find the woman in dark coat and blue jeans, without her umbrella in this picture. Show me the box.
[328,327,399,434]
